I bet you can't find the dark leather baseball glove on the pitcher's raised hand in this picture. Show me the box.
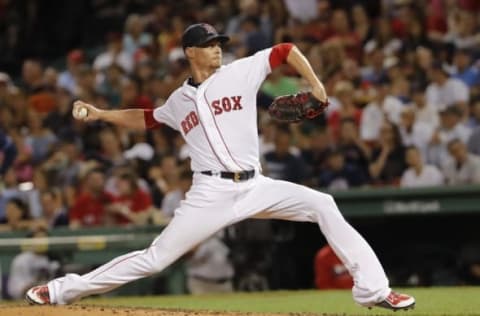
[268,92,329,123]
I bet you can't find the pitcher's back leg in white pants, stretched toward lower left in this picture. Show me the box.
[48,208,232,304]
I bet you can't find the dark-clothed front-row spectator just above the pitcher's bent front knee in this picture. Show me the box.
[318,149,368,190]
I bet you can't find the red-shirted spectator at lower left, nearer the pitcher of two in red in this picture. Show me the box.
[107,173,153,225]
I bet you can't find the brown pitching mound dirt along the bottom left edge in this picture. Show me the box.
[0,305,326,316]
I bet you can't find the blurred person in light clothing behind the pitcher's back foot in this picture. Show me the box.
[7,229,60,300]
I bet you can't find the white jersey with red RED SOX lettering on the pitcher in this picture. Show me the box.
[153,48,272,171]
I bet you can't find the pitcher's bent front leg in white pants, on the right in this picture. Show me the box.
[242,178,391,305]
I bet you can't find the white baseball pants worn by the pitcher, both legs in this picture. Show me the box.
[48,173,390,306]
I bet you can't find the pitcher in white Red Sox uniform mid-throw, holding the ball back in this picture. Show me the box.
[26,23,415,310]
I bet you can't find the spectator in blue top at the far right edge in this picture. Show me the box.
[452,49,480,88]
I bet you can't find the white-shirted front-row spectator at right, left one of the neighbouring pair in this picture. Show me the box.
[400,146,443,188]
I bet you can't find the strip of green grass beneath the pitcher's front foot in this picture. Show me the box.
[82,287,480,316]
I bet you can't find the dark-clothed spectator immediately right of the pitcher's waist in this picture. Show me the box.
[263,128,306,183]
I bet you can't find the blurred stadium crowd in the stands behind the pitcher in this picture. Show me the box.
[0,0,480,231]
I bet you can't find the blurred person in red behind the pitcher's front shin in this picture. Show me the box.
[314,245,353,290]
